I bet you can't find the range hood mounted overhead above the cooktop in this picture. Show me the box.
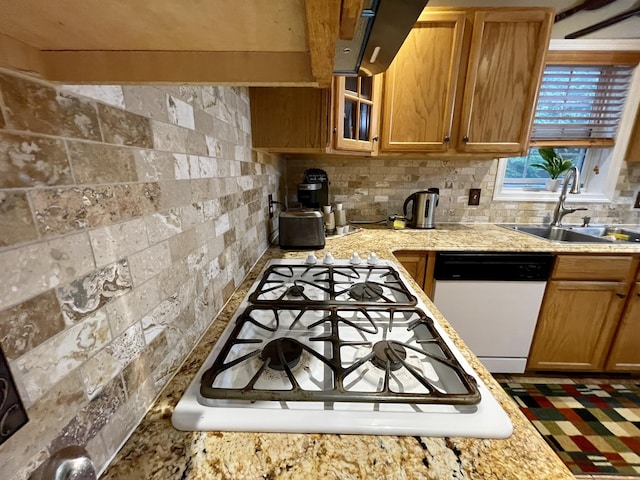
[333,0,428,76]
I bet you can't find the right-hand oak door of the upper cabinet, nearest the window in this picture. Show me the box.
[458,9,552,153]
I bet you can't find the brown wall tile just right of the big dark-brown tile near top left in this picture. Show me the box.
[98,104,153,148]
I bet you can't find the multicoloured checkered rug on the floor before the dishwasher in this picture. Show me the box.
[501,382,640,477]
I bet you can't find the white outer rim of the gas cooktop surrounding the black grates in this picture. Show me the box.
[172,259,513,438]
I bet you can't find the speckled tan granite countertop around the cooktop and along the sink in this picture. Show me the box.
[102,224,640,480]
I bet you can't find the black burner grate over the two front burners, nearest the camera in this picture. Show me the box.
[200,304,480,405]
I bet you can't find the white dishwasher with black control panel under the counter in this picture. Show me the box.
[433,252,554,373]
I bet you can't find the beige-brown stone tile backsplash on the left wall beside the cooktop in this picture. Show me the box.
[0,70,284,479]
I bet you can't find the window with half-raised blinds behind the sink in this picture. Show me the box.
[494,60,635,201]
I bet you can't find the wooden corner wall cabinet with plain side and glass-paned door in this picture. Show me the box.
[249,75,382,154]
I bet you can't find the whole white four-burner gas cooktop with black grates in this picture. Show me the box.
[172,254,513,438]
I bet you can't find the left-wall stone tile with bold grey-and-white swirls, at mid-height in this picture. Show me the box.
[56,259,132,324]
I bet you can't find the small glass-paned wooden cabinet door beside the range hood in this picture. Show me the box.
[334,76,380,152]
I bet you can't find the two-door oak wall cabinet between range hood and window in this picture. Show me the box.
[381,8,553,156]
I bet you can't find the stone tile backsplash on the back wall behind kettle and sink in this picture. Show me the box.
[286,156,640,225]
